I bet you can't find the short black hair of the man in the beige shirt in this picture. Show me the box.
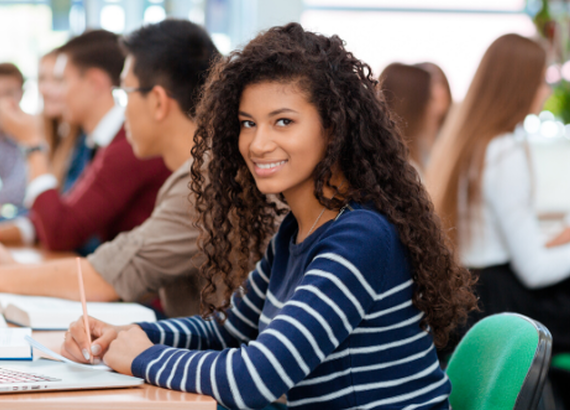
[122,19,218,117]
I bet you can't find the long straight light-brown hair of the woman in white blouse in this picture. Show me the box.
[426,34,546,245]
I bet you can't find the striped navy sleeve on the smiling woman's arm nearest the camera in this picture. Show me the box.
[132,224,383,408]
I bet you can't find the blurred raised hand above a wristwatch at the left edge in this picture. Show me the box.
[0,98,45,146]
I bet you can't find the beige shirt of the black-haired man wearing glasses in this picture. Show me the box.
[87,160,203,317]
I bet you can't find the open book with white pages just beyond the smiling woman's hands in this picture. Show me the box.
[0,293,156,330]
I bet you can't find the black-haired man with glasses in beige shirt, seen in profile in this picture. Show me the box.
[0,19,218,316]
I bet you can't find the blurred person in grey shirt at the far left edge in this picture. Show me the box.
[0,63,26,208]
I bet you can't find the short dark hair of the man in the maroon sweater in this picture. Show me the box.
[57,30,125,86]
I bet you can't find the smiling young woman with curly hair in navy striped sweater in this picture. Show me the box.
[62,24,474,409]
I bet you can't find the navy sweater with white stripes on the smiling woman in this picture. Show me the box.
[132,204,451,410]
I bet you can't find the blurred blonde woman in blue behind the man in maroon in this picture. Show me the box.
[38,49,84,192]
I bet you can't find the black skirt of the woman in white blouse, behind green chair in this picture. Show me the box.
[468,264,570,353]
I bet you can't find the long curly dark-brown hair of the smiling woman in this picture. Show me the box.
[191,23,476,346]
